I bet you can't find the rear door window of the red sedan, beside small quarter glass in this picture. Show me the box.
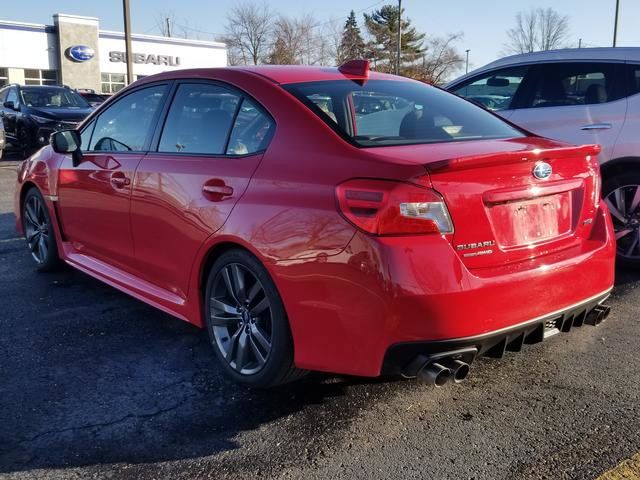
[158,83,241,155]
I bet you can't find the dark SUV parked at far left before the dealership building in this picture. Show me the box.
[0,84,93,158]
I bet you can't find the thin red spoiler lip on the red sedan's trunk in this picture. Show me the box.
[425,145,601,173]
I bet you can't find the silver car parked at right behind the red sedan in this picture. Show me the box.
[447,48,640,267]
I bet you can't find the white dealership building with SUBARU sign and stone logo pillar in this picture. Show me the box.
[0,13,227,93]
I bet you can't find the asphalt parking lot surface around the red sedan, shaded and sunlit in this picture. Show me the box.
[0,153,640,479]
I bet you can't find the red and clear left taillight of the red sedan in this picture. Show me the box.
[336,179,453,235]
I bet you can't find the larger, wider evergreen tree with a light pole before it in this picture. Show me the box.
[364,5,425,73]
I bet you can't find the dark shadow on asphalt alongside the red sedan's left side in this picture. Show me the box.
[0,258,398,473]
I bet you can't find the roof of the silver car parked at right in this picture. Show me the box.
[450,47,640,85]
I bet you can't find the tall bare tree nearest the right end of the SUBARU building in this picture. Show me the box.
[224,2,273,65]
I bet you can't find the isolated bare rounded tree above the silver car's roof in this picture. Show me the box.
[505,8,569,53]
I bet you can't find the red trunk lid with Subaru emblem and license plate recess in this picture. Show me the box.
[364,137,600,269]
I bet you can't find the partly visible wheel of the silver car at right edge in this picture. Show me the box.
[602,171,640,268]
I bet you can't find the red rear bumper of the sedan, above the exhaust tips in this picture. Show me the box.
[272,202,615,376]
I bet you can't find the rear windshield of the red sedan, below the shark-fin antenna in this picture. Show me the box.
[284,80,524,147]
